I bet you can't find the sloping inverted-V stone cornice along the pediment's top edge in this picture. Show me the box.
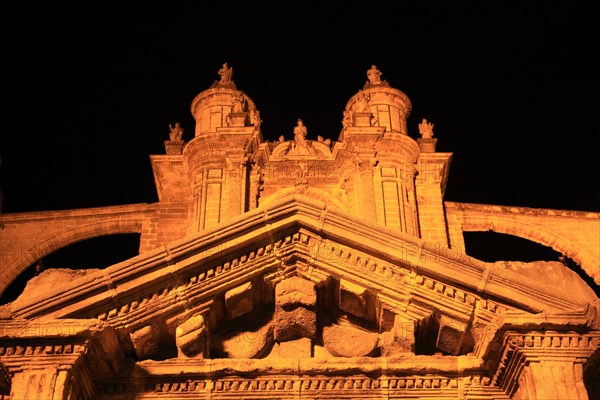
[12,195,596,324]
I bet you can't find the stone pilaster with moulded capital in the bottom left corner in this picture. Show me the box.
[0,319,124,400]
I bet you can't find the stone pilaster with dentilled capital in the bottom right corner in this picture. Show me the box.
[493,331,600,400]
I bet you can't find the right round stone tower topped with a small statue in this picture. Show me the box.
[340,66,419,236]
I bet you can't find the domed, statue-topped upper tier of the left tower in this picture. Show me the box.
[191,63,260,136]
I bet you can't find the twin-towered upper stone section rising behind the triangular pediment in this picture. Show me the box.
[141,63,452,250]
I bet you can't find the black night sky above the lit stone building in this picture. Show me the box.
[0,1,600,296]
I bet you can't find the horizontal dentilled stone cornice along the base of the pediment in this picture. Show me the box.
[105,356,508,400]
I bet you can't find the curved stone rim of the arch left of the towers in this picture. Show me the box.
[0,219,142,295]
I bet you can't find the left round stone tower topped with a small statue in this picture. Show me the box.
[183,64,260,232]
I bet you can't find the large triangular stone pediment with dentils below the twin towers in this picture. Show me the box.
[12,194,586,358]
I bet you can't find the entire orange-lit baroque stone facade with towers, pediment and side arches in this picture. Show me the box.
[0,64,600,400]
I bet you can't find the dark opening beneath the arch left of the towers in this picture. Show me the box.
[0,233,140,305]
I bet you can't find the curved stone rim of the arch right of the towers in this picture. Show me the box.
[462,216,594,274]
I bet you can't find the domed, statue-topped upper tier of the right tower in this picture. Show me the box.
[343,65,412,135]
